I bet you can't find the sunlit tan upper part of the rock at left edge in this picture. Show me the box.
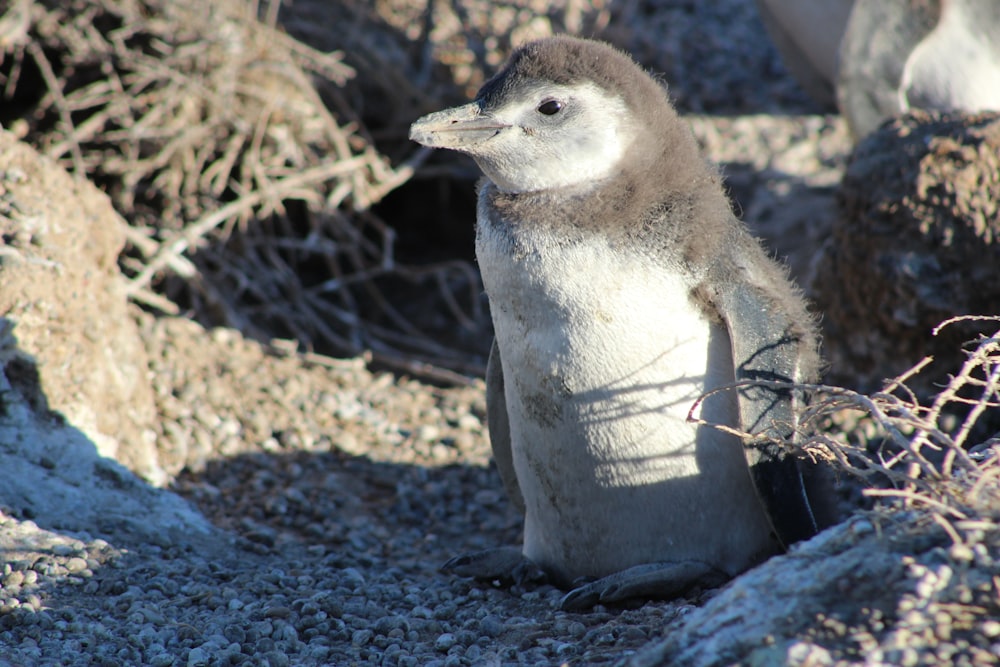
[0,132,165,484]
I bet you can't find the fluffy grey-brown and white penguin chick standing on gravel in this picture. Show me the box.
[410,37,819,609]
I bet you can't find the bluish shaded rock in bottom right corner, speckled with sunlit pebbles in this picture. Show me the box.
[624,511,1000,667]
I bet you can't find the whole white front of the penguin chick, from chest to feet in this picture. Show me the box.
[477,215,775,581]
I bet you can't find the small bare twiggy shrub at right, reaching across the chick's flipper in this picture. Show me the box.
[692,316,1000,543]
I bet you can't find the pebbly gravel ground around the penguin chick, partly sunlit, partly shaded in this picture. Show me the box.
[0,0,928,667]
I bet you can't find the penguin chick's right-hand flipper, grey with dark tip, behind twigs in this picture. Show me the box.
[719,281,818,547]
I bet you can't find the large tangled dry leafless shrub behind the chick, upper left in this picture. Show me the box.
[0,0,478,379]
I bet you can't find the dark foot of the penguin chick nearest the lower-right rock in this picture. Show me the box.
[559,560,730,611]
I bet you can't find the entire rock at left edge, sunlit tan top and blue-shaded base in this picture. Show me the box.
[0,132,222,552]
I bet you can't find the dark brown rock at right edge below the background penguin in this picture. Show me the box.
[812,112,1000,397]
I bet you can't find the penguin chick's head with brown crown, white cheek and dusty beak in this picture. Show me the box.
[410,37,674,193]
